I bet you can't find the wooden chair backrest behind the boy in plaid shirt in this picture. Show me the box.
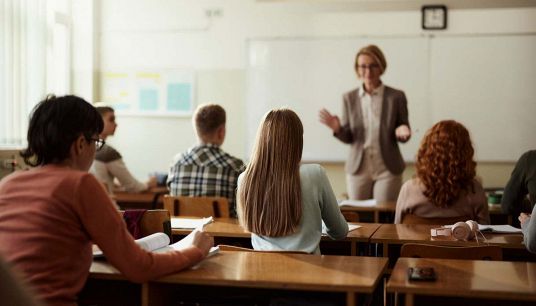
[164,195,229,218]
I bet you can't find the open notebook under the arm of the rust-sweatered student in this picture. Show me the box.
[93,233,220,258]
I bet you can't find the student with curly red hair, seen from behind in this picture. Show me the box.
[395,120,490,224]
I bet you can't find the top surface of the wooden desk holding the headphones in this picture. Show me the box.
[370,224,525,249]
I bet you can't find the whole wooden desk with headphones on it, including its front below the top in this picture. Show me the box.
[370,224,536,261]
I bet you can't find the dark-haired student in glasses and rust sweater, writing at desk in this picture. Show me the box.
[0,96,213,306]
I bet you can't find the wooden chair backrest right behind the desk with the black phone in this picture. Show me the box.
[400,243,502,260]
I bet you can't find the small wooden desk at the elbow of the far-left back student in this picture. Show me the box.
[112,187,169,209]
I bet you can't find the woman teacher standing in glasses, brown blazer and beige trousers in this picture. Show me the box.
[319,45,411,201]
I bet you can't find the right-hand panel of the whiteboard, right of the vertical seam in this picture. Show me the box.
[430,35,536,161]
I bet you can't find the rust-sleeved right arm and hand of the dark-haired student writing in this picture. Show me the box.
[77,176,206,282]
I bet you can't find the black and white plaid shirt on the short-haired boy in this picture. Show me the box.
[167,144,246,217]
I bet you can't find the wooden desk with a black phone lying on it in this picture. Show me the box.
[387,258,536,306]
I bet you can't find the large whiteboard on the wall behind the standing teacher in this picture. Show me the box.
[246,35,536,162]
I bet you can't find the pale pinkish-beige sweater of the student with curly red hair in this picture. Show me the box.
[395,179,490,224]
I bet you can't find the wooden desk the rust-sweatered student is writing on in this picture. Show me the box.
[88,251,387,306]
